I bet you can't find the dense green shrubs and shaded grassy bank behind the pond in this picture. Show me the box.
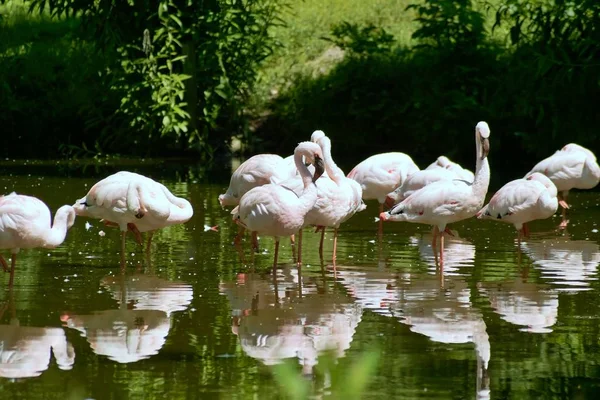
[0,0,600,175]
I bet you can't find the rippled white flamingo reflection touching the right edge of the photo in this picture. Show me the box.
[521,232,600,291]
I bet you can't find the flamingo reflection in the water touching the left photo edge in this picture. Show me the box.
[0,290,75,379]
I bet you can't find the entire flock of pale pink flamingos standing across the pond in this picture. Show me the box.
[0,121,600,286]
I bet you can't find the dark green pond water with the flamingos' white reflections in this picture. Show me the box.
[0,163,600,399]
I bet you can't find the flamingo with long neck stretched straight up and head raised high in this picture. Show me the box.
[380,121,490,266]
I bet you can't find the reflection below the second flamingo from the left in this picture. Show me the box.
[61,274,193,363]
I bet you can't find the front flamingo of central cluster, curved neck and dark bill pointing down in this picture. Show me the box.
[231,142,323,271]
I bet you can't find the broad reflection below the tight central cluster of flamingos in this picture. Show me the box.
[220,269,362,375]
